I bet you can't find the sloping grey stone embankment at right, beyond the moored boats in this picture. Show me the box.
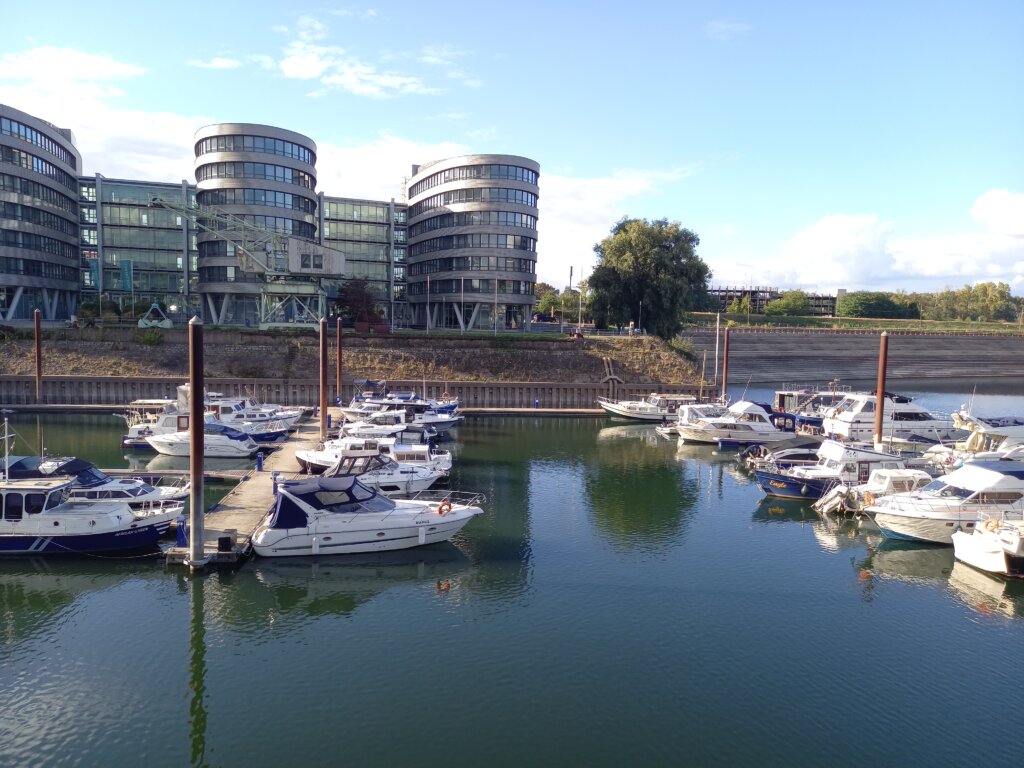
[687,328,1024,390]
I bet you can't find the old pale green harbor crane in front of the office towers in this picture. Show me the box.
[150,198,345,330]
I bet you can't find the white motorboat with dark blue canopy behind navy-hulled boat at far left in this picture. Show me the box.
[7,456,190,511]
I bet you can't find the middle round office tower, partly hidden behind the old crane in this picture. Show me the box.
[196,123,316,325]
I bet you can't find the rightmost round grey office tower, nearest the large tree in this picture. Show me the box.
[408,155,540,330]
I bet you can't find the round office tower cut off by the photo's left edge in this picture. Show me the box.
[0,104,82,321]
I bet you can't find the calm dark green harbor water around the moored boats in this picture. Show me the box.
[0,387,1024,766]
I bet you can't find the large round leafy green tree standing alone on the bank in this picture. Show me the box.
[588,218,711,339]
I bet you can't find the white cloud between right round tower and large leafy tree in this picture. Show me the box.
[537,168,692,289]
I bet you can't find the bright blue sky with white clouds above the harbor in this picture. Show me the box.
[0,0,1024,295]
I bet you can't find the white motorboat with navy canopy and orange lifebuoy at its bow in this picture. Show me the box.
[252,476,483,557]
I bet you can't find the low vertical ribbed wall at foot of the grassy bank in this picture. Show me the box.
[0,373,698,410]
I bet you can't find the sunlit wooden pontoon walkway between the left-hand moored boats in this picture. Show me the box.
[166,409,327,565]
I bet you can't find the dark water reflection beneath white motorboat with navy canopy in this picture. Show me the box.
[247,542,475,629]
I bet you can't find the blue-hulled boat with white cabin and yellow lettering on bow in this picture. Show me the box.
[754,440,906,499]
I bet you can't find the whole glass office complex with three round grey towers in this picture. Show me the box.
[0,104,540,330]
